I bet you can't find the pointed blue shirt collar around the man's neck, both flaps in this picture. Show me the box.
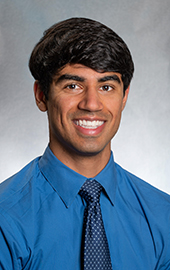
[39,146,117,207]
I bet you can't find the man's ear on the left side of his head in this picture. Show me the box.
[34,81,47,112]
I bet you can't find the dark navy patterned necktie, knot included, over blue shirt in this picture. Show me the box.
[79,180,112,270]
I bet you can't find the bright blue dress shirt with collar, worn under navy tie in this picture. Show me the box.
[0,147,170,270]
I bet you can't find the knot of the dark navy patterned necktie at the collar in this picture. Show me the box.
[79,180,102,204]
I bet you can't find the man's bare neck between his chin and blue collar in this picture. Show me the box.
[50,143,111,178]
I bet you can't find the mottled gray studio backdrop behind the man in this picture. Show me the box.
[0,0,170,193]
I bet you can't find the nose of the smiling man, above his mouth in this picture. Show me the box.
[78,87,103,112]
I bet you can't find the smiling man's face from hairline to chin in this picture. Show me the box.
[36,64,128,156]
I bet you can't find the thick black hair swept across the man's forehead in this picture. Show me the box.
[29,18,134,98]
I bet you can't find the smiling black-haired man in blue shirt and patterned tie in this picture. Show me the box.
[0,18,170,270]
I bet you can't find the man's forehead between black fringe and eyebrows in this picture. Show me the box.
[54,64,123,84]
